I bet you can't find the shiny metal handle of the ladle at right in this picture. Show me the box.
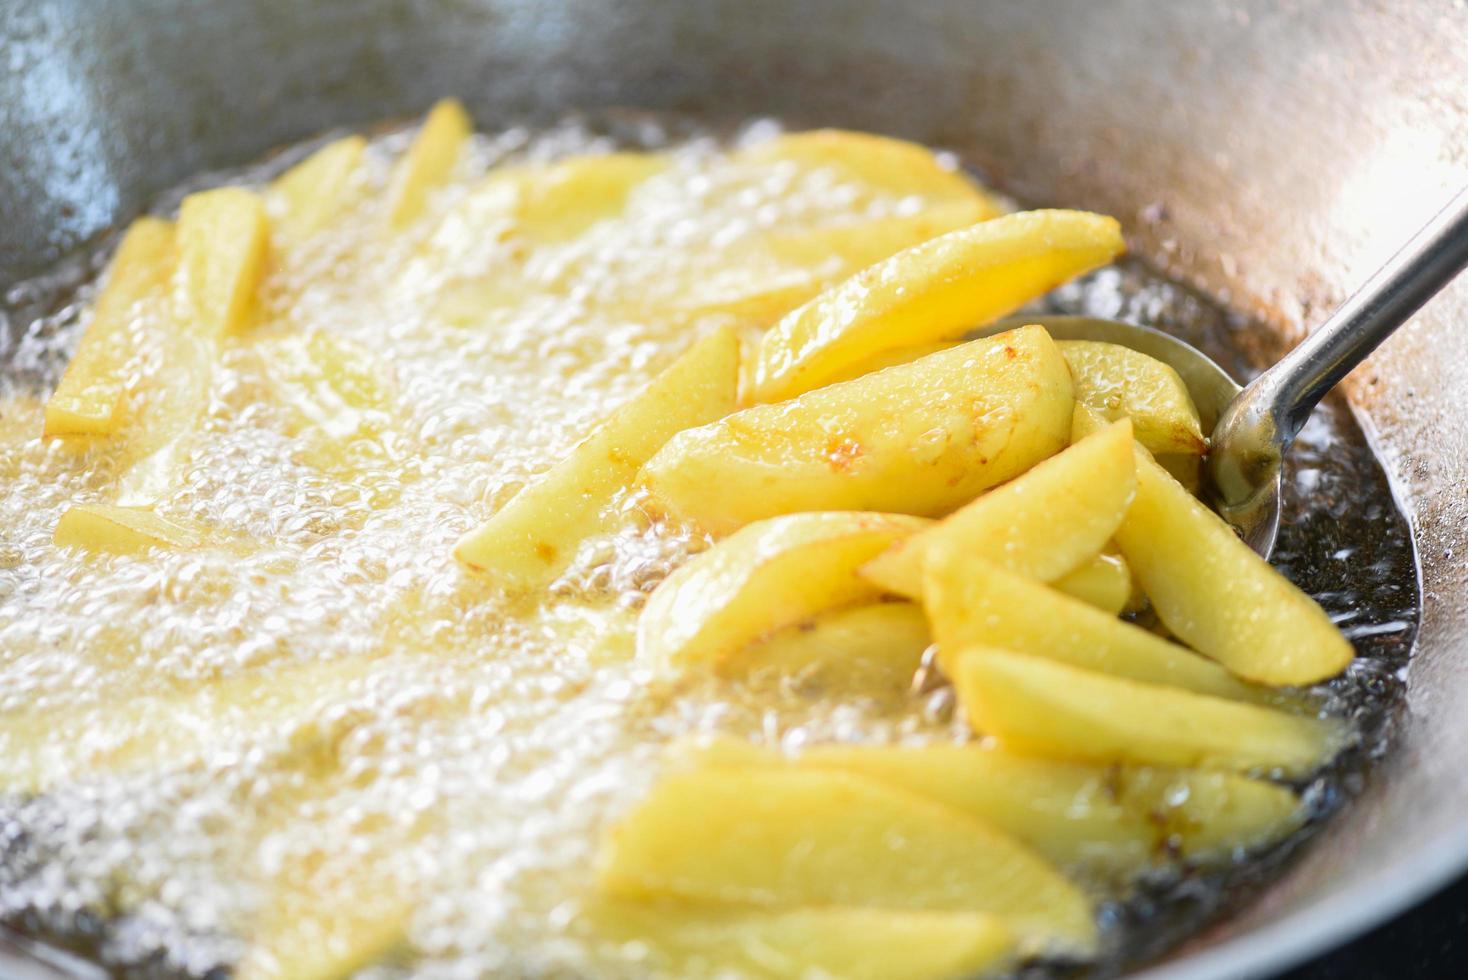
[1210,188,1468,505]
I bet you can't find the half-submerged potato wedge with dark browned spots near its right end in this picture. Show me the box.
[668,738,1304,883]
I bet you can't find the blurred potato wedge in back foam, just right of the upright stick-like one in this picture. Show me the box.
[517,153,669,242]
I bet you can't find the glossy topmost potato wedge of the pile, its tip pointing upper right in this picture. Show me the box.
[755,211,1124,402]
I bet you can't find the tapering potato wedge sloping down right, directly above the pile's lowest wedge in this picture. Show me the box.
[923,549,1267,700]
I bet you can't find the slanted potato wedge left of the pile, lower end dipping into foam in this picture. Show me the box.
[454,329,740,588]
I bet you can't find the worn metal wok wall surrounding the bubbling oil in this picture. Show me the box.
[0,0,1468,980]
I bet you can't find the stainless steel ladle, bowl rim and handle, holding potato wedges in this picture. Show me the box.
[982,188,1468,557]
